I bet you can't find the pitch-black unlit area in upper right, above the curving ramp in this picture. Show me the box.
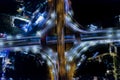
[72,0,120,27]
